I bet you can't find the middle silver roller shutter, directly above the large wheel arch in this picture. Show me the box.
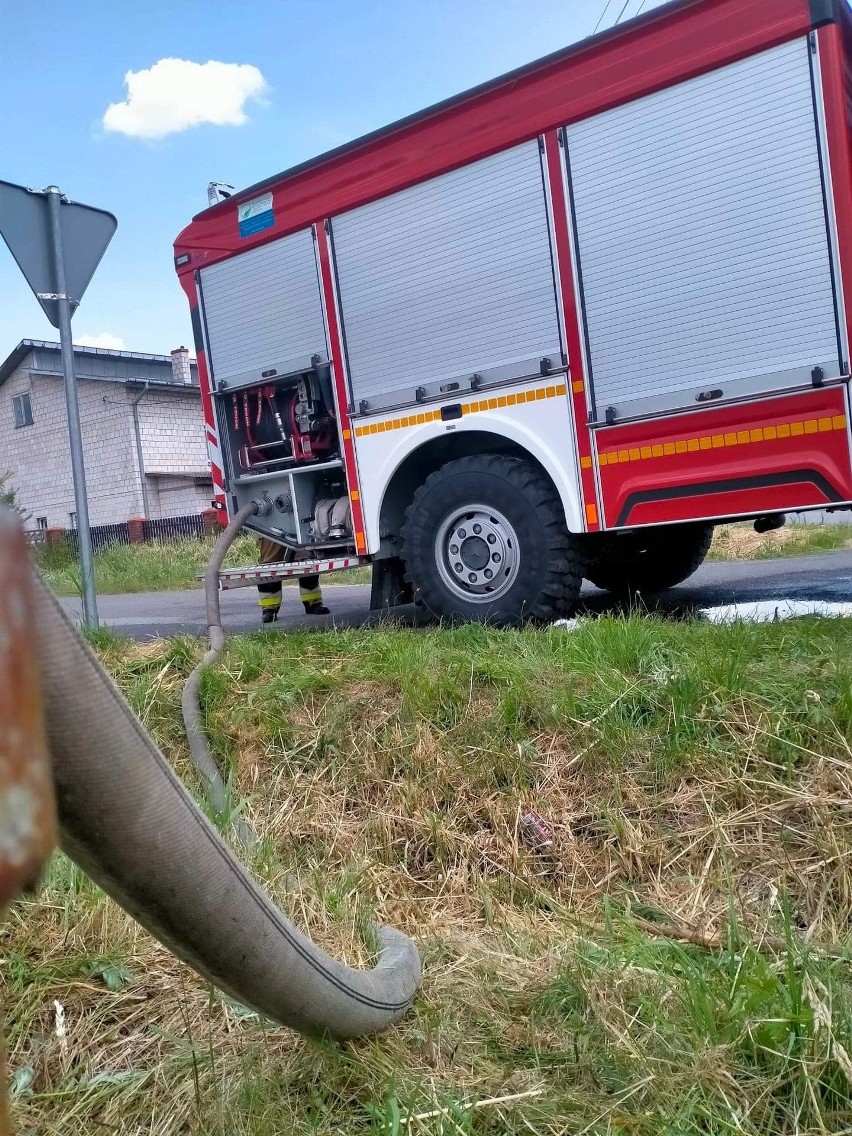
[333,142,560,406]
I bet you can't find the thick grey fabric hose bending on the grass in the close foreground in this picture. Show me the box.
[35,572,420,1039]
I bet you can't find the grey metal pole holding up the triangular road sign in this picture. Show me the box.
[44,185,98,627]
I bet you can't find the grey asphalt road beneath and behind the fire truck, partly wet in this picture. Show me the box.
[55,551,852,638]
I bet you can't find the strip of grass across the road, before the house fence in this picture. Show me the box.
[34,534,370,595]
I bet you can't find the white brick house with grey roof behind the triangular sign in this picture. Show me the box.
[0,340,212,528]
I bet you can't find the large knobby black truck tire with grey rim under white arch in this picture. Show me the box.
[402,453,583,627]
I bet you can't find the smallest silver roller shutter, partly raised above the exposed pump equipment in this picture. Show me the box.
[200,229,327,383]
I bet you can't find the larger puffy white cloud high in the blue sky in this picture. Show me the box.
[103,59,268,139]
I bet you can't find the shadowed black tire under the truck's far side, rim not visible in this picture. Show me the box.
[586,524,713,594]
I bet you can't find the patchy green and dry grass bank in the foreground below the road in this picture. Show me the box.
[0,618,852,1136]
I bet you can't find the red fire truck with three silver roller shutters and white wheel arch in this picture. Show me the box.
[175,0,852,623]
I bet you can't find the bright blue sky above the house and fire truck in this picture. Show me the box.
[0,0,660,359]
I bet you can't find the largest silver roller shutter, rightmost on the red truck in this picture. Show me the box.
[566,40,840,418]
